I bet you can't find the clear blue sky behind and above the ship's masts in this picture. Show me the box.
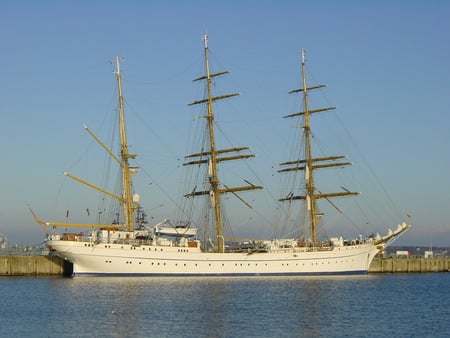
[0,1,450,245]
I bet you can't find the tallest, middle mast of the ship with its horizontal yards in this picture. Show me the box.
[183,35,263,252]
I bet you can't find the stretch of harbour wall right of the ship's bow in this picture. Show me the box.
[369,256,450,273]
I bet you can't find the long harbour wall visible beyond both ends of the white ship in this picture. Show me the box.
[0,256,450,276]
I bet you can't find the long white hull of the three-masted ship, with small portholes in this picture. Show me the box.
[47,240,379,276]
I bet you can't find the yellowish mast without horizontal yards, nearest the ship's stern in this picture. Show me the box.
[114,56,137,231]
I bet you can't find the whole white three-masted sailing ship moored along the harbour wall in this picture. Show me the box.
[32,35,410,276]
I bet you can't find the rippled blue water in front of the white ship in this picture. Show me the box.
[0,273,450,337]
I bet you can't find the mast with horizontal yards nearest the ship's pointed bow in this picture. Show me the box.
[278,49,358,244]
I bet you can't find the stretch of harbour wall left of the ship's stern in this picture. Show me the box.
[0,256,72,276]
